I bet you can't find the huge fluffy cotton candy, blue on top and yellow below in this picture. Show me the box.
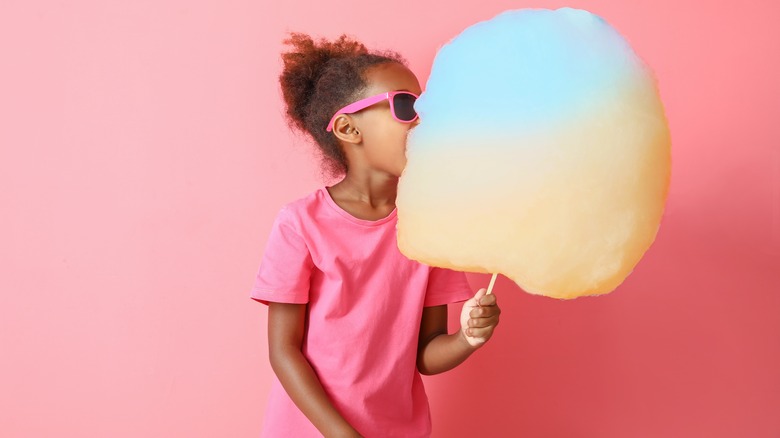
[396,8,671,299]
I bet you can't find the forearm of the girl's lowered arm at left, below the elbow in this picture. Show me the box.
[271,347,360,437]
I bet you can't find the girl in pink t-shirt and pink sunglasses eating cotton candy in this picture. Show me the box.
[251,33,500,437]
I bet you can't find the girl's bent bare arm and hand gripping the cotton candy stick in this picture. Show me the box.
[417,289,501,375]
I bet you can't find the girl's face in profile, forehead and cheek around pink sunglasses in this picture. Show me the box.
[354,62,422,177]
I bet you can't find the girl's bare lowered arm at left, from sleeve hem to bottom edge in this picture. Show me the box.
[268,303,360,437]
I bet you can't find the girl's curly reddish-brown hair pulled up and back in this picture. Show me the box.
[279,32,407,176]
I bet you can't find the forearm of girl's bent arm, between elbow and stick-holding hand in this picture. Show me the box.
[417,330,479,375]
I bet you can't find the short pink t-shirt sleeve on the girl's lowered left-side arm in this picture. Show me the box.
[249,207,314,304]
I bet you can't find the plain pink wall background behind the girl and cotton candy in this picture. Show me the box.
[0,0,780,437]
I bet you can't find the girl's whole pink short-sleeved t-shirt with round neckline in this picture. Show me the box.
[250,187,473,437]
